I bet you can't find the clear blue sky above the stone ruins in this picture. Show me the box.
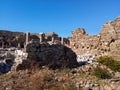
[0,0,120,37]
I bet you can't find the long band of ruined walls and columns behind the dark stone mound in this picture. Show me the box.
[0,17,120,56]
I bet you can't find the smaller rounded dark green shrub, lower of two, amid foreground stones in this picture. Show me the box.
[93,67,111,79]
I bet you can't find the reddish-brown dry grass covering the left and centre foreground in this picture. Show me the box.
[0,63,77,90]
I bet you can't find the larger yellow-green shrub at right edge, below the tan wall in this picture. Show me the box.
[97,56,120,72]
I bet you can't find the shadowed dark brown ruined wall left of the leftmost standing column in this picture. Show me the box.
[0,30,25,48]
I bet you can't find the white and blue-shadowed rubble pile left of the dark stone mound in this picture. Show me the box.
[0,50,29,74]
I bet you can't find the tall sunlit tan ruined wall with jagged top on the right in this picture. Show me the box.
[69,17,120,57]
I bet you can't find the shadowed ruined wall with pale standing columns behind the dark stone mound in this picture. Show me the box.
[0,30,69,48]
